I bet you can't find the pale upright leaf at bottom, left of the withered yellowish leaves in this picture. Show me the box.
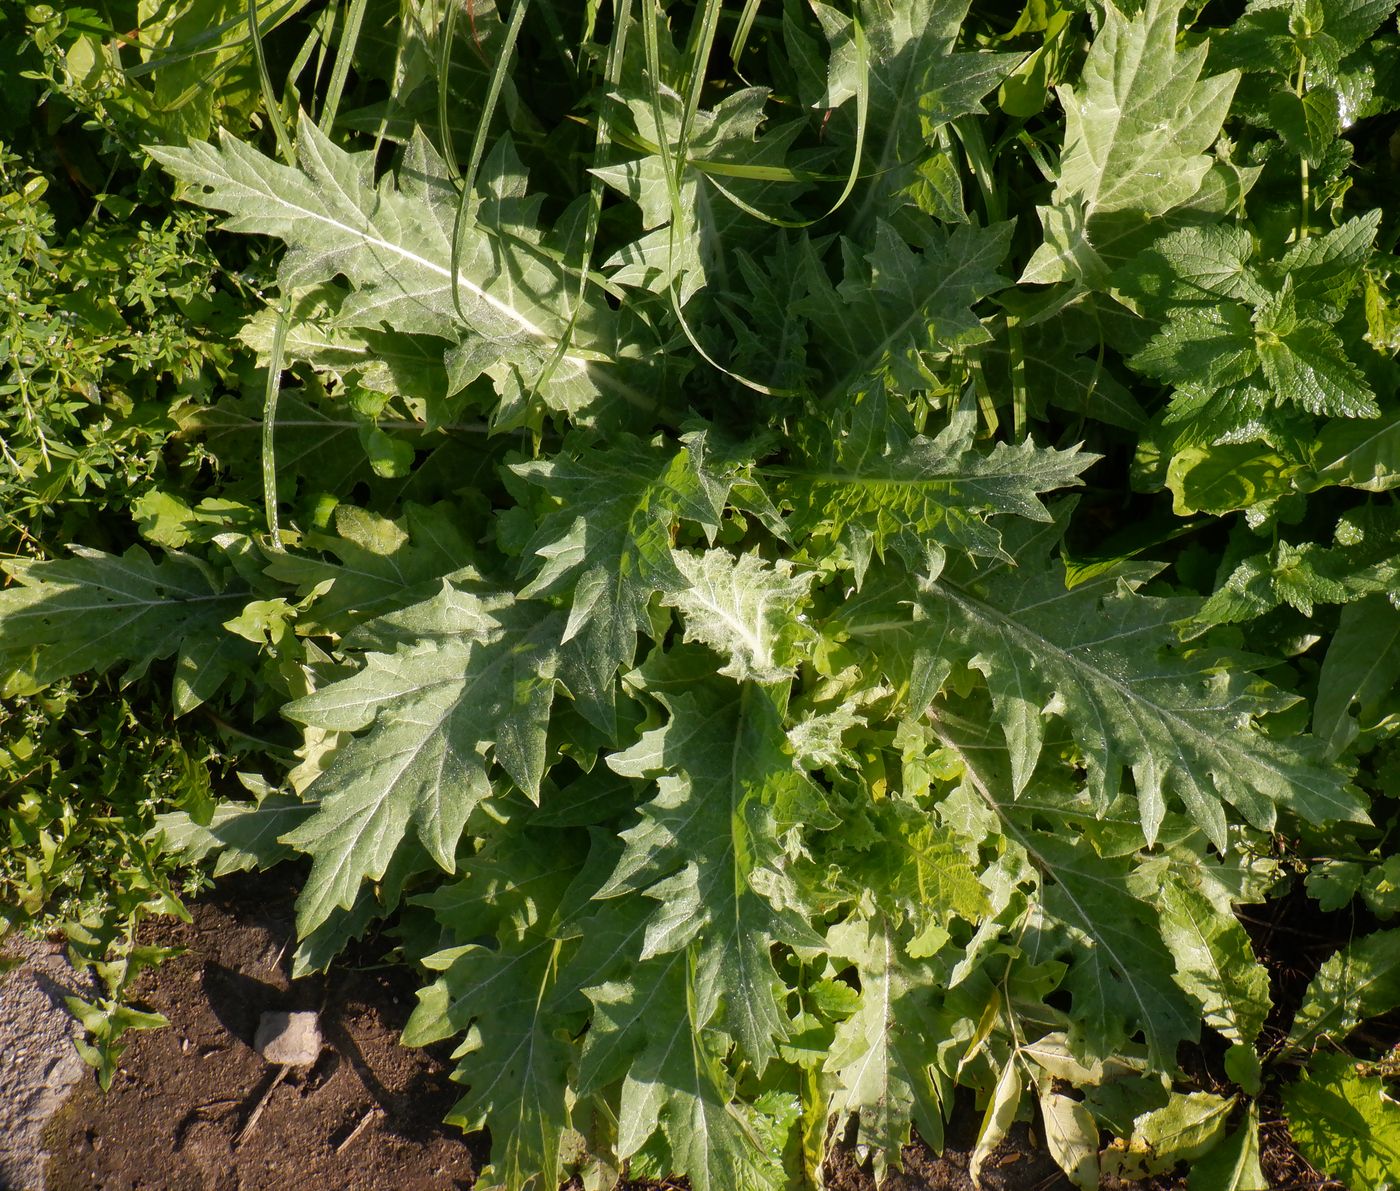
[825,915,951,1181]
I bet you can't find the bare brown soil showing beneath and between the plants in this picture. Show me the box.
[32,873,1340,1191]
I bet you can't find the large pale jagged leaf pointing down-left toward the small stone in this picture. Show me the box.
[284,585,561,932]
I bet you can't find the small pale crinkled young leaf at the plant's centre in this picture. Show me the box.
[662,550,813,683]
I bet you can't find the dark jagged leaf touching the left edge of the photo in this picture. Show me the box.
[0,546,248,710]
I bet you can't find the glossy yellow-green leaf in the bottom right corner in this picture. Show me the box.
[1282,1054,1400,1191]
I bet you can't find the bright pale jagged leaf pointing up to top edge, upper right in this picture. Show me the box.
[1022,0,1239,284]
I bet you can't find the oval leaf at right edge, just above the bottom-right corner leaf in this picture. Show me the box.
[1287,931,1400,1051]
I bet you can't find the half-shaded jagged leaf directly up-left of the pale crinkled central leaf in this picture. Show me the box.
[512,434,731,726]
